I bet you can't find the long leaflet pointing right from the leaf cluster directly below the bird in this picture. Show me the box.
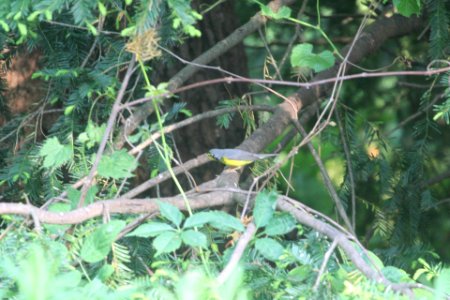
[183,211,245,232]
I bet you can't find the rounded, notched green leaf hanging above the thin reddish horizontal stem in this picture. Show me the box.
[291,44,334,72]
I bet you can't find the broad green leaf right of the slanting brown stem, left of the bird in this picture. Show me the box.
[98,149,137,179]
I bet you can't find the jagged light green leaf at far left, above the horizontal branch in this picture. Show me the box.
[39,137,73,168]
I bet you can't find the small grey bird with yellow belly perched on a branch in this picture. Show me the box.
[208,149,277,167]
